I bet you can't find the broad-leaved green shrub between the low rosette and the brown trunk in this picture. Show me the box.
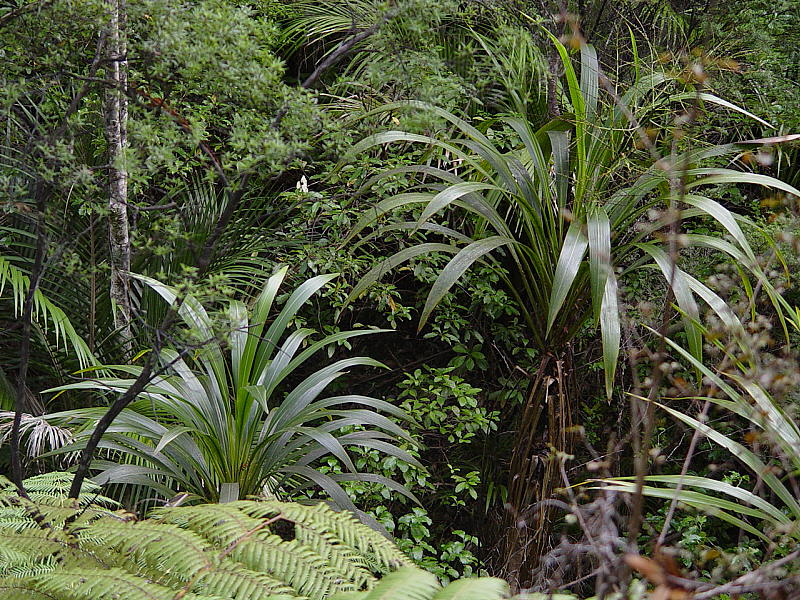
[321,367,499,581]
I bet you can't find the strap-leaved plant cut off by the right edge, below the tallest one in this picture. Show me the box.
[594,328,800,556]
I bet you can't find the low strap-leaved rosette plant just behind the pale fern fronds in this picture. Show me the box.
[43,268,416,509]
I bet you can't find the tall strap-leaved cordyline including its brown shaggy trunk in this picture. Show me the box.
[340,34,800,580]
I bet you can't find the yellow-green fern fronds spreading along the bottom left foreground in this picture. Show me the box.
[0,472,508,600]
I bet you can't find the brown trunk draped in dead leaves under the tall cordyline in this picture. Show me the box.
[502,353,574,590]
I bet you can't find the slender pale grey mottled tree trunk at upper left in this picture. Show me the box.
[104,0,131,352]
